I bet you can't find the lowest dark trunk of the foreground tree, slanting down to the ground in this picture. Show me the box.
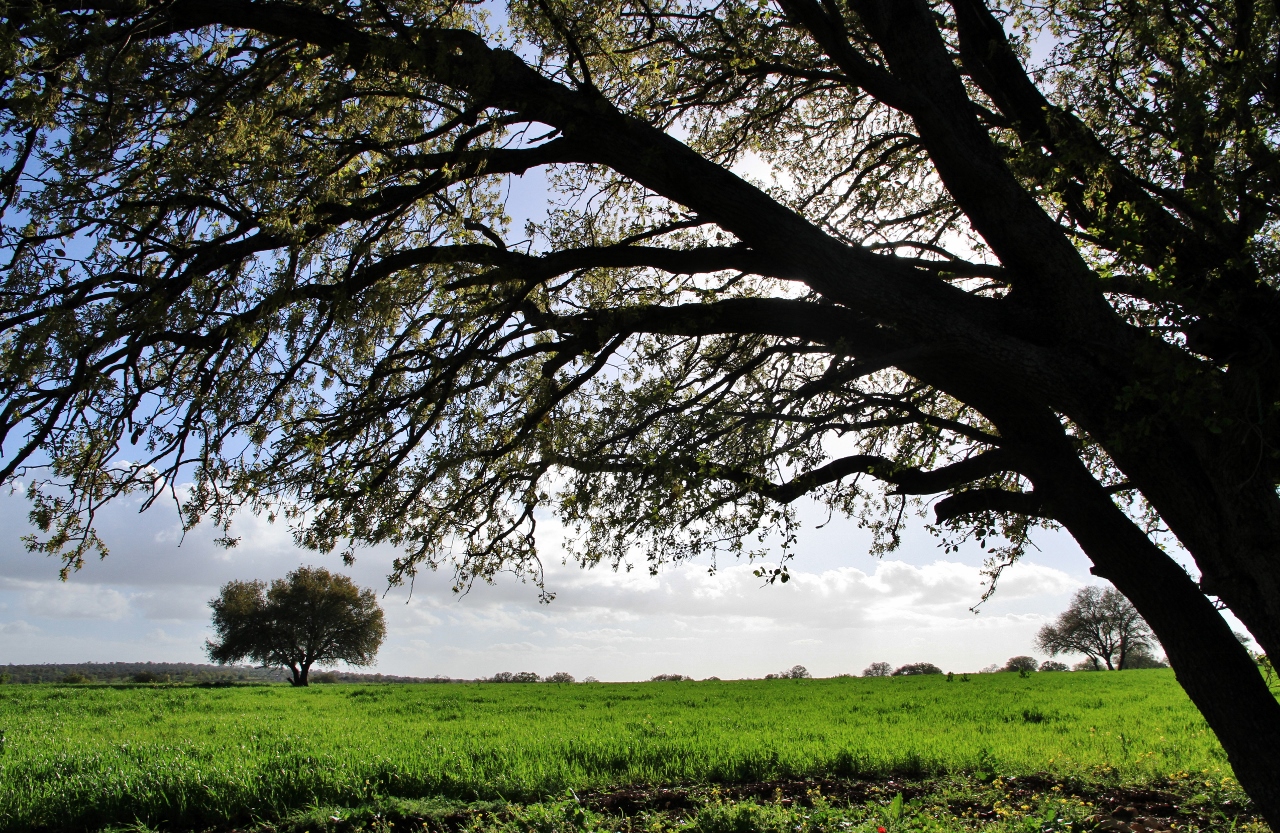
[1033,459,1280,830]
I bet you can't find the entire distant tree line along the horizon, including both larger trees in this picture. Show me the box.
[0,567,1198,686]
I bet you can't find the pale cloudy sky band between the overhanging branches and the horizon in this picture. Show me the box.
[0,494,1121,681]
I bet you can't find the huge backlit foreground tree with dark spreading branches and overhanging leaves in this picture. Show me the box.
[0,0,1280,828]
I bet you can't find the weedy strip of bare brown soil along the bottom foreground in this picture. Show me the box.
[99,775,1267,833]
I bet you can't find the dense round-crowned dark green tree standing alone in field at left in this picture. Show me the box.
[206,567,387,686]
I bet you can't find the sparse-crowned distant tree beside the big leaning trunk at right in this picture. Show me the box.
[1036,586,1156,670]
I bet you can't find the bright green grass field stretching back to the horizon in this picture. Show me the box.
[0,670,1230,830]
